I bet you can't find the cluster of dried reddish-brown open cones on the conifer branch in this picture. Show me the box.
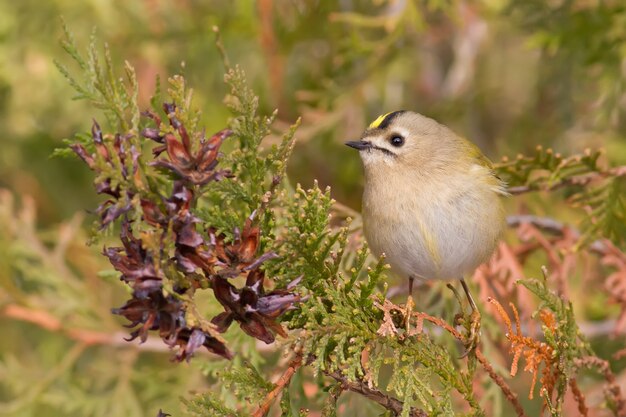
[71,103,300,361]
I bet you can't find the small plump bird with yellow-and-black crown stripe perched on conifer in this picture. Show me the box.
[346,110,507,356]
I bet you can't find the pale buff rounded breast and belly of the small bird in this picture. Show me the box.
[363,170,504,280]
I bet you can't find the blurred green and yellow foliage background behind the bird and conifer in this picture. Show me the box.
[0,0,626,416]
